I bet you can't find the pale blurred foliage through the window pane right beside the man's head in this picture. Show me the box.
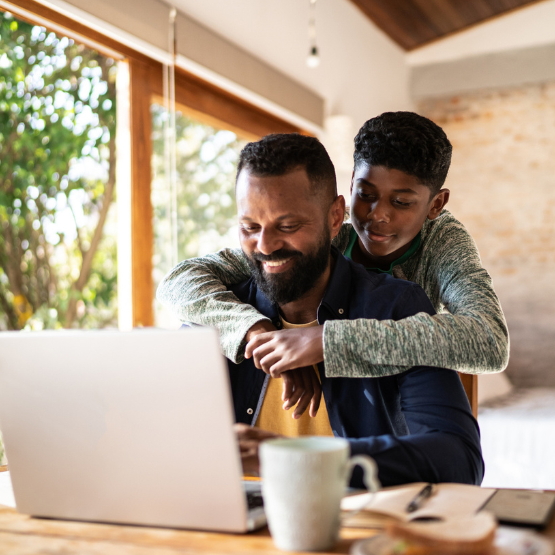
[152,105,246,281]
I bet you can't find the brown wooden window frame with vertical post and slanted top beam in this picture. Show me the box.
[5,0,302,326]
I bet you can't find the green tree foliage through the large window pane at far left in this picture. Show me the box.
[0,12,116,329]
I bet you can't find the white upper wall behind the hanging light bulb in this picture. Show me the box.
[175,0,412,129]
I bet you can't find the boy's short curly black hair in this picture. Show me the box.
[354,112,453,195]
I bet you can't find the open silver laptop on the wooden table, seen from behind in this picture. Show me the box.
[0,328,265,532]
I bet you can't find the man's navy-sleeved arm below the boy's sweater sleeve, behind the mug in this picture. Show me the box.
[349,367,484,487]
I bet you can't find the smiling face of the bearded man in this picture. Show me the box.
[236,169,331,305]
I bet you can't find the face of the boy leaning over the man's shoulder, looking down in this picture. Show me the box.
[351,164,449,264]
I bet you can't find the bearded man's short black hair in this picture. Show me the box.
[237,133,337,203]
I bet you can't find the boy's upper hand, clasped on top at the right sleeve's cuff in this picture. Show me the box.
[245,326,324,378]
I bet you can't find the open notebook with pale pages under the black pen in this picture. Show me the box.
[341,482,496,527]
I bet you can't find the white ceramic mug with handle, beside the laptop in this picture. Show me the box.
[260,437,380,551]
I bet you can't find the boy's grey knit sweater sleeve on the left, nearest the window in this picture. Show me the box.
[156,222,351,364]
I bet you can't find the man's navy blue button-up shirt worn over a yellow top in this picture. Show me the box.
[228,248,484,487]
